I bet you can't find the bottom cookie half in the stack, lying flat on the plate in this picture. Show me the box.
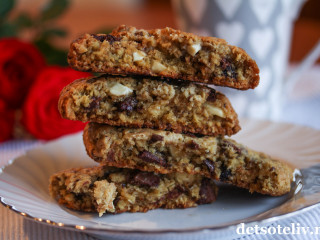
[49,166,217,216]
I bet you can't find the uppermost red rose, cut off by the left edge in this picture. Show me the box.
[0,38,45,108]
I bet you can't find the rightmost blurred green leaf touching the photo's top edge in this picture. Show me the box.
[40,0,70,21]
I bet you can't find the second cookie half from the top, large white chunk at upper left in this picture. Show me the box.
[59,75,240,136]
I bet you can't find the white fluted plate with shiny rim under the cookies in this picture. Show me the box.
[0,120,320,239]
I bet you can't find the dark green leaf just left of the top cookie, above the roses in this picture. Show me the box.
[34,39,68,66]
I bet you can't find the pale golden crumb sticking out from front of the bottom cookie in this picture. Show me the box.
[93,180,117,217]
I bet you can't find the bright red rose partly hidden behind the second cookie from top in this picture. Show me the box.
[22,67,90,140]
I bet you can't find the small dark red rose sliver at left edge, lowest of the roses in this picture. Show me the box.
[0,99,14,142]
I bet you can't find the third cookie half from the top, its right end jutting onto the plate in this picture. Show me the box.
[83,123,293,196]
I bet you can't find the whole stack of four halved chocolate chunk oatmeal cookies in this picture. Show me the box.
[50,26,292,216]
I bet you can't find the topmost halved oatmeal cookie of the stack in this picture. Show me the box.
[68,25,259,90]
